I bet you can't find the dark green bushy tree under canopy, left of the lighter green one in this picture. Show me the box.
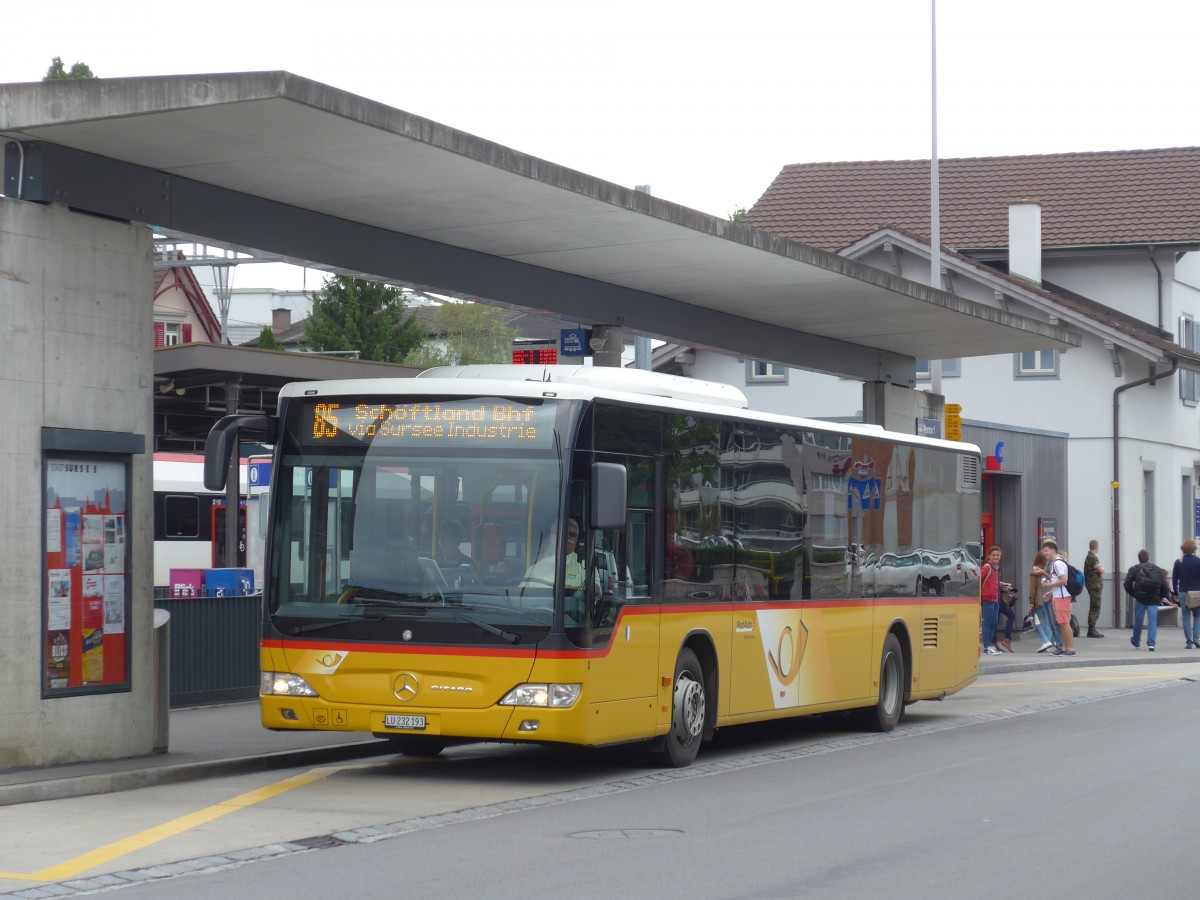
[304,275,425,362]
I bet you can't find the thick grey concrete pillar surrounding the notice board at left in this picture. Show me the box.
[0,198,155,768]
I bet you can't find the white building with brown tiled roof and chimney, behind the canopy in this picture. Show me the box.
[655,148,1200,628]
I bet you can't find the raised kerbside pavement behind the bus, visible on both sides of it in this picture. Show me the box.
[7,628,1200,806]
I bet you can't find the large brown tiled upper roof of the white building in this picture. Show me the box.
[744,146,1200,252]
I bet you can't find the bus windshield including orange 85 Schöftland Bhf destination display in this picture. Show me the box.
[269,398,563,643]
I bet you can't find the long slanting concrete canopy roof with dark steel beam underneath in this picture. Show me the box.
[0,72,1079,384]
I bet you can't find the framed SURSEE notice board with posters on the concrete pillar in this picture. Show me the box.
[42,454,130,697]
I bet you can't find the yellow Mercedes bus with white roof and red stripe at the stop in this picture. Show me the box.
[205,366,980,766]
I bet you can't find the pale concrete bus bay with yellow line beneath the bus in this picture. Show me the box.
[0,654,1200,896]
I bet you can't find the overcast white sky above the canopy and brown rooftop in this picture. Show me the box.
[0,0,1200,289]
